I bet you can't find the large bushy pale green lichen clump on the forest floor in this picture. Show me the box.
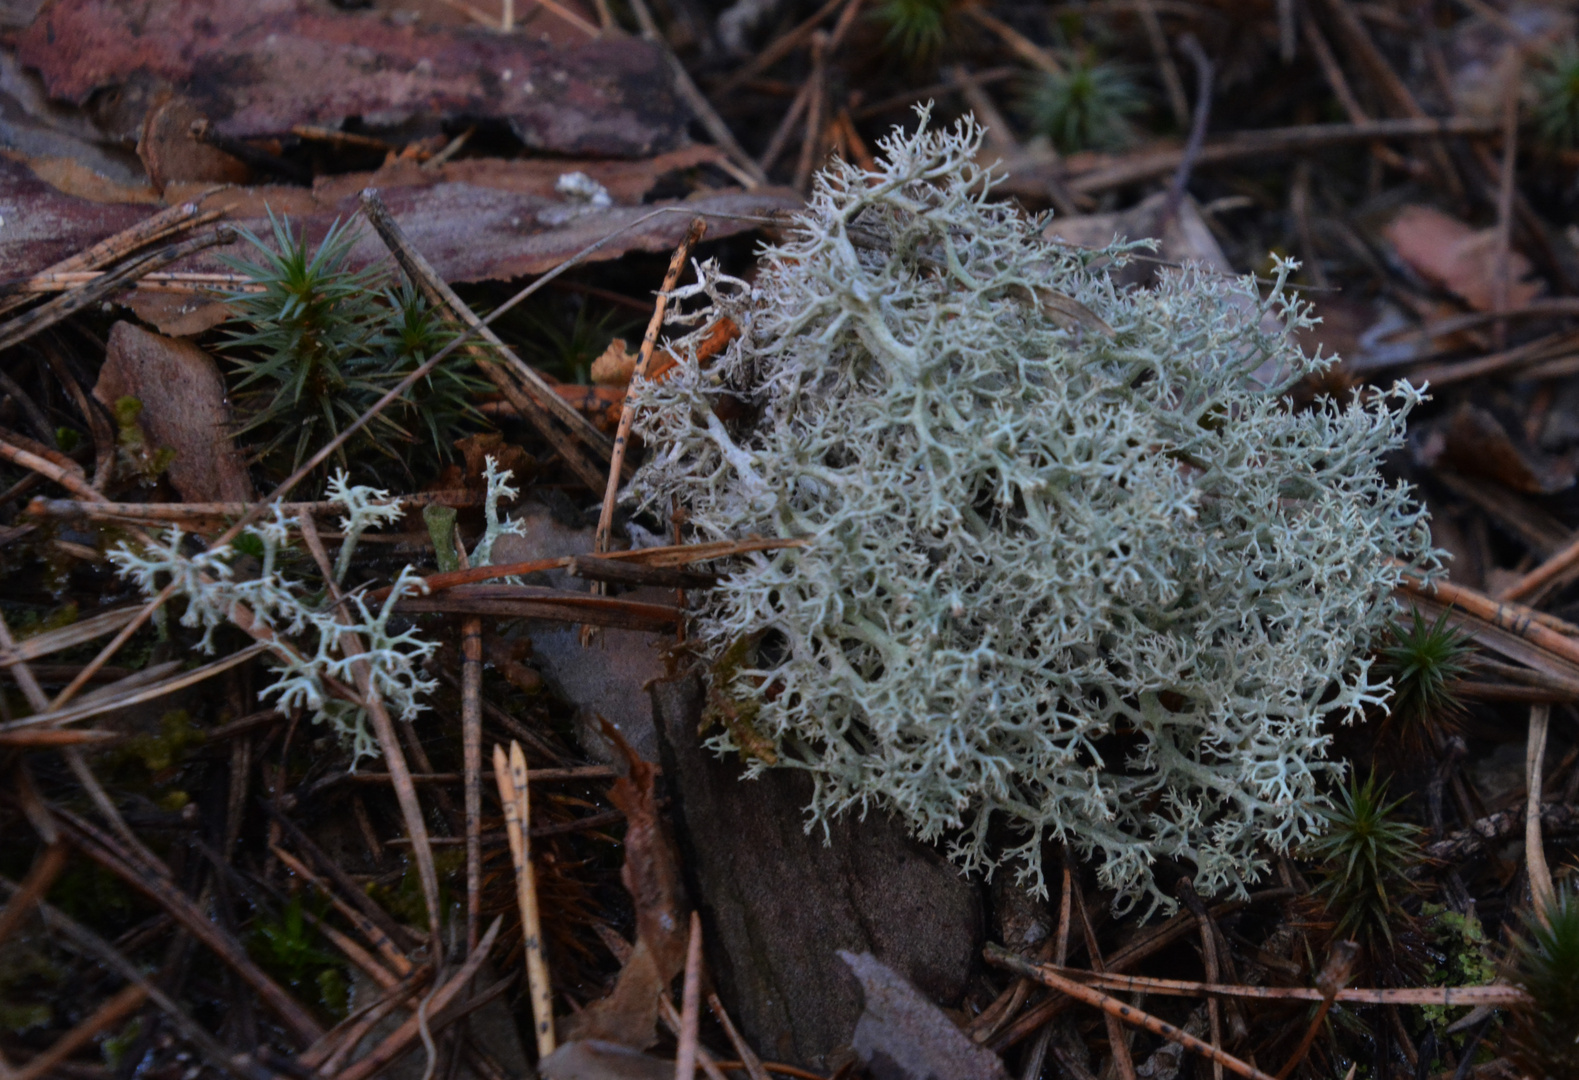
[628,117,1434,906]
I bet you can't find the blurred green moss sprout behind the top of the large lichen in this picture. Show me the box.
[1020,57,1146,153]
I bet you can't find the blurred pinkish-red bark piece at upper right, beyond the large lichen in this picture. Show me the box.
[1383,207,1541,311]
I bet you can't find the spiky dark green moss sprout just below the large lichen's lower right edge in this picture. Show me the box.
[1307,774,1420,962]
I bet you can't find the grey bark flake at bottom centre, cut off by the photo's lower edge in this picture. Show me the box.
[838,949,1009,1080]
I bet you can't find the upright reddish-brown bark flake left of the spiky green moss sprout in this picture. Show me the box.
[93,322,256,502]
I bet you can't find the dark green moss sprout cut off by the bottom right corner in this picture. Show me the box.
[1508,887,1579,1080]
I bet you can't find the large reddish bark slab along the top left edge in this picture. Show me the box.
[17,0,687,156]
